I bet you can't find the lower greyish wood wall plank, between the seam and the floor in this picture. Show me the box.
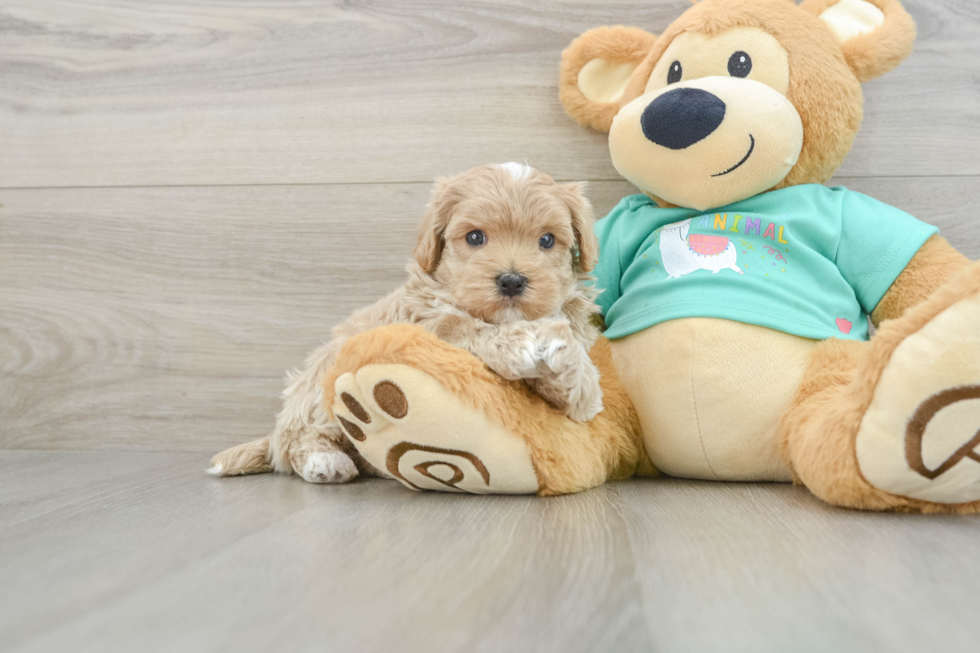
[0,178,980,452]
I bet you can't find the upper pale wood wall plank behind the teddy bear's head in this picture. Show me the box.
[0,0,980,188]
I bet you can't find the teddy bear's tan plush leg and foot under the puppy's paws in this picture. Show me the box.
[321,324,655,496]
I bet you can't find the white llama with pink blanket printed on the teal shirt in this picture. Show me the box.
[660,218,744,279]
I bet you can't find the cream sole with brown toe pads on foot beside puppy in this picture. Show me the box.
[333,365,538,494]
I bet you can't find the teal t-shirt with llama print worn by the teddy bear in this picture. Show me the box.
[595,184,937,340]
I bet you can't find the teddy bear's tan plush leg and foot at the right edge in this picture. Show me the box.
[781,263,980,513]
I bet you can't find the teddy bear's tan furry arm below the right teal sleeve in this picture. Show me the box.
[871,235,970,326]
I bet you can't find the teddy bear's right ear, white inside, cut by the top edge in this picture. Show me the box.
[800,0,915,82]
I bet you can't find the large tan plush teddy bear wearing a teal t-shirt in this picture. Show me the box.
[324,0,980,513]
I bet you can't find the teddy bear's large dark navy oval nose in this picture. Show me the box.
[640,88,725,150]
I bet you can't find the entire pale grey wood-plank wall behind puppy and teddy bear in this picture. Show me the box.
[0,0,980,452]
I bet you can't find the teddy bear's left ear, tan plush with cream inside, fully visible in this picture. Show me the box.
[559,25,657,132]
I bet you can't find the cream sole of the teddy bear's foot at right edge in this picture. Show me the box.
[856,294,980,504]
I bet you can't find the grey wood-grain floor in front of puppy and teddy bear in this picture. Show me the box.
[0,451,980,653]
